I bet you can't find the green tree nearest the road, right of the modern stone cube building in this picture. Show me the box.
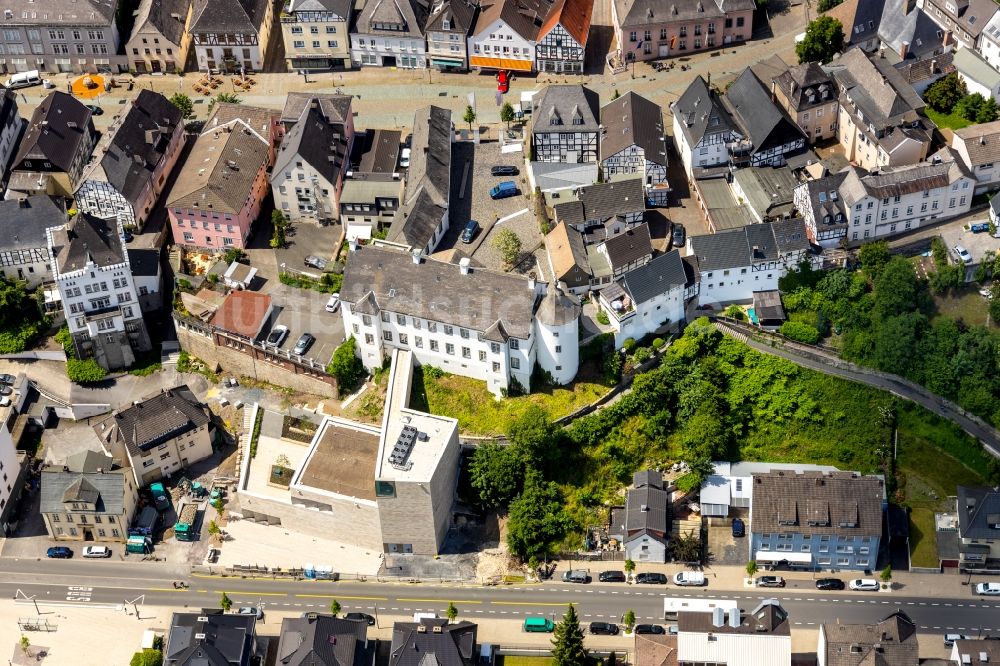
[507,469,572,560]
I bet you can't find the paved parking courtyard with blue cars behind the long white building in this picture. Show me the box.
[437,142,541,269]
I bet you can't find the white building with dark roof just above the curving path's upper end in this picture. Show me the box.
[689,219,809,305]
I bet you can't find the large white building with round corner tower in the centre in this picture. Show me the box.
[340,243,580,395]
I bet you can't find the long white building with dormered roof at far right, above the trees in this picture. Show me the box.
[840,148,976,243]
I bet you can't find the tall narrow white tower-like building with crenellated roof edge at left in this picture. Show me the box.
[48,213,152,370]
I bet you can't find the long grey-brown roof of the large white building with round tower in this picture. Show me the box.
[340,245,536,340]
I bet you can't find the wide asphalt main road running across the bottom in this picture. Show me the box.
[7,560,1000,634]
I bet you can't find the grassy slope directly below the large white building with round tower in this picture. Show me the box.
[410,368,609,435]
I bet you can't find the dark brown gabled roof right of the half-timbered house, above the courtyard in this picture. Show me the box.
[601,91,667,165]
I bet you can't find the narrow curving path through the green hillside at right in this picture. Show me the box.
[715,321,1000,458]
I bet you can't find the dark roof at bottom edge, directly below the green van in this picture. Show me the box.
[389,618,478,666]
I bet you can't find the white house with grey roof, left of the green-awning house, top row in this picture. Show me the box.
[351,0,429,69]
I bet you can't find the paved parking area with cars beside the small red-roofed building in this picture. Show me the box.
[267,283,344,366]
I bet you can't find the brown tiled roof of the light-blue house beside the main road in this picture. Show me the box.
[750,470,885,537]
